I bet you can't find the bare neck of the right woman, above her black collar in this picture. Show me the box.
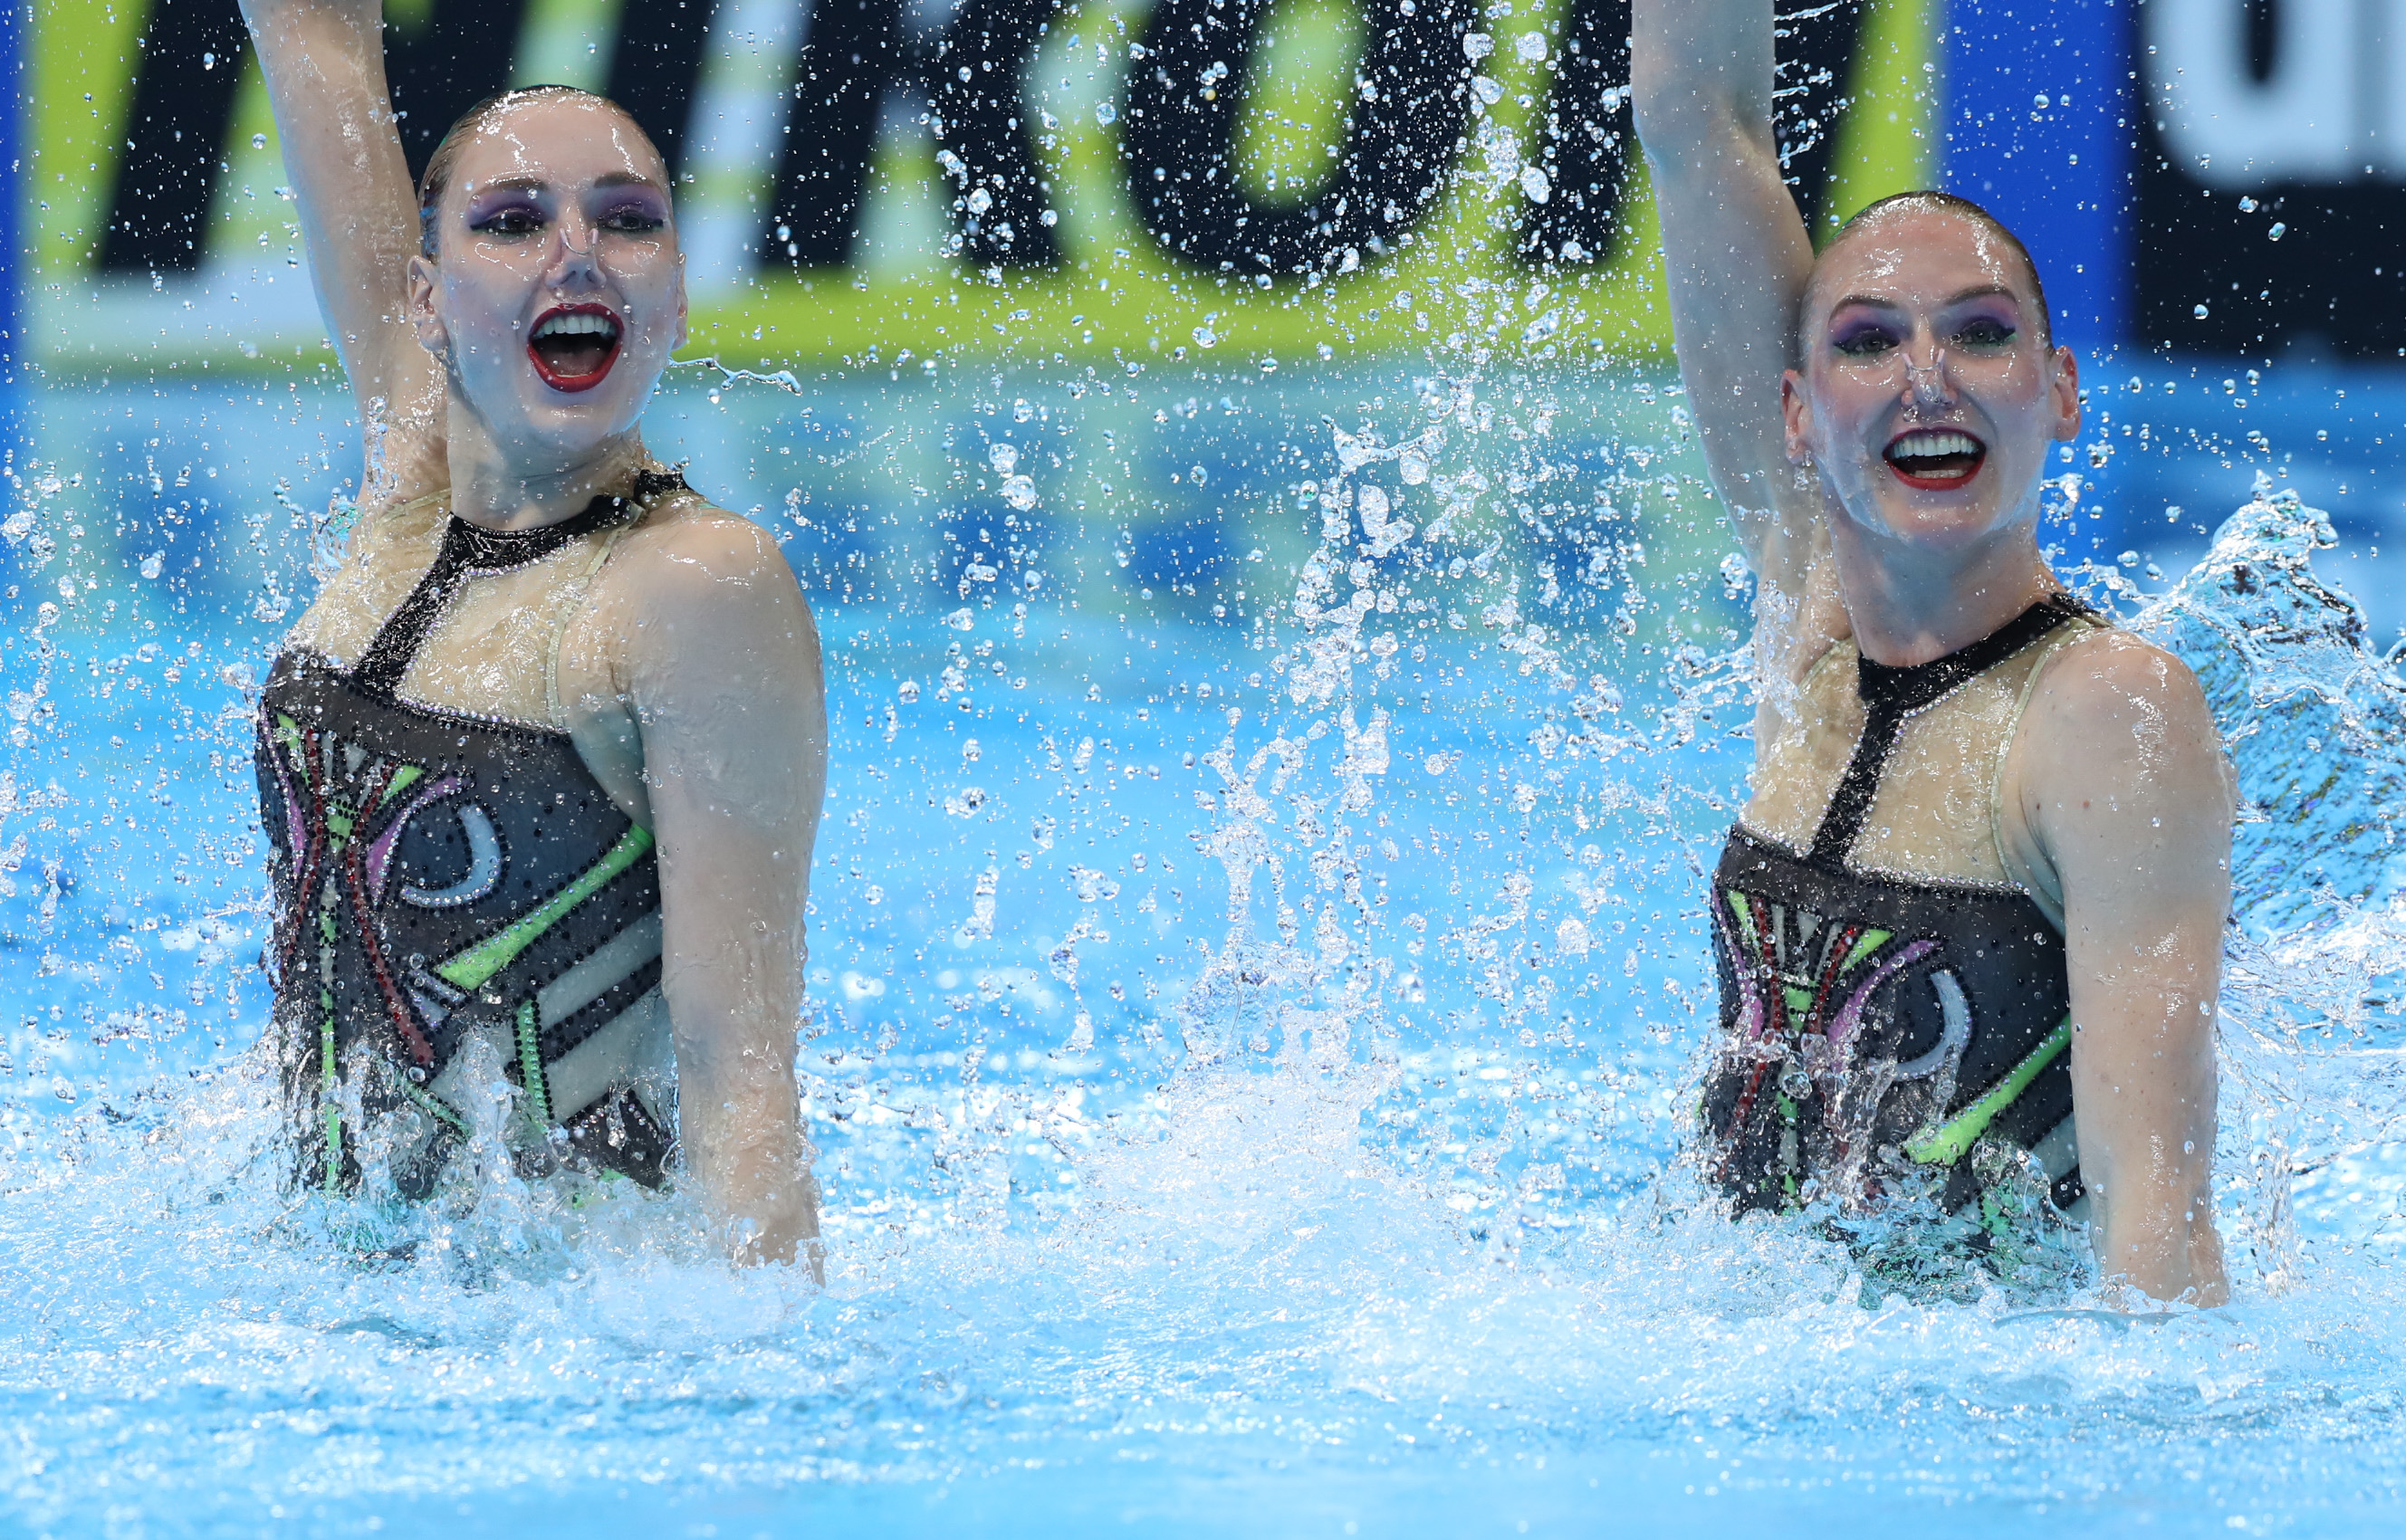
[1831,512,2059,666]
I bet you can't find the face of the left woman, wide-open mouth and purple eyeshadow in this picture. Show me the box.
[411,94,685,474]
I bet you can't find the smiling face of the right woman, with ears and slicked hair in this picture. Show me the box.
[1783,202,2081,551]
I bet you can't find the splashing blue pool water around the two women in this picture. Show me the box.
[0,366,2406,1535]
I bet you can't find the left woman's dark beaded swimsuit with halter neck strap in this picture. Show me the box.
[255,474,684,1199]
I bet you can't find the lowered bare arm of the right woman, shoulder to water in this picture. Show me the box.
[2021,633,2233,1305]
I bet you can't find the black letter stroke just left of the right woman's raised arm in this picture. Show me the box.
[1523,0,1634,263]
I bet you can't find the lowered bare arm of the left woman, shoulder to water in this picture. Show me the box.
[628,515,828,1261]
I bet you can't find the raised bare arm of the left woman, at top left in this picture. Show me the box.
[243,0,447,508]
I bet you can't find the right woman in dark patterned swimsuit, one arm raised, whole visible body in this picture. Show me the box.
[1634,0,2235,1305]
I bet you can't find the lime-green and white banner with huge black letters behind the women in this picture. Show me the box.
[24,0,1934,373]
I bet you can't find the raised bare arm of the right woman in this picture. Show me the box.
[1631,0,1821,597]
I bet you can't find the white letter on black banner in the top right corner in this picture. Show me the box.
[2142,0,2367,190]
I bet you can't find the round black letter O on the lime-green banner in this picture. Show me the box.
[1119,0,1470,274]
